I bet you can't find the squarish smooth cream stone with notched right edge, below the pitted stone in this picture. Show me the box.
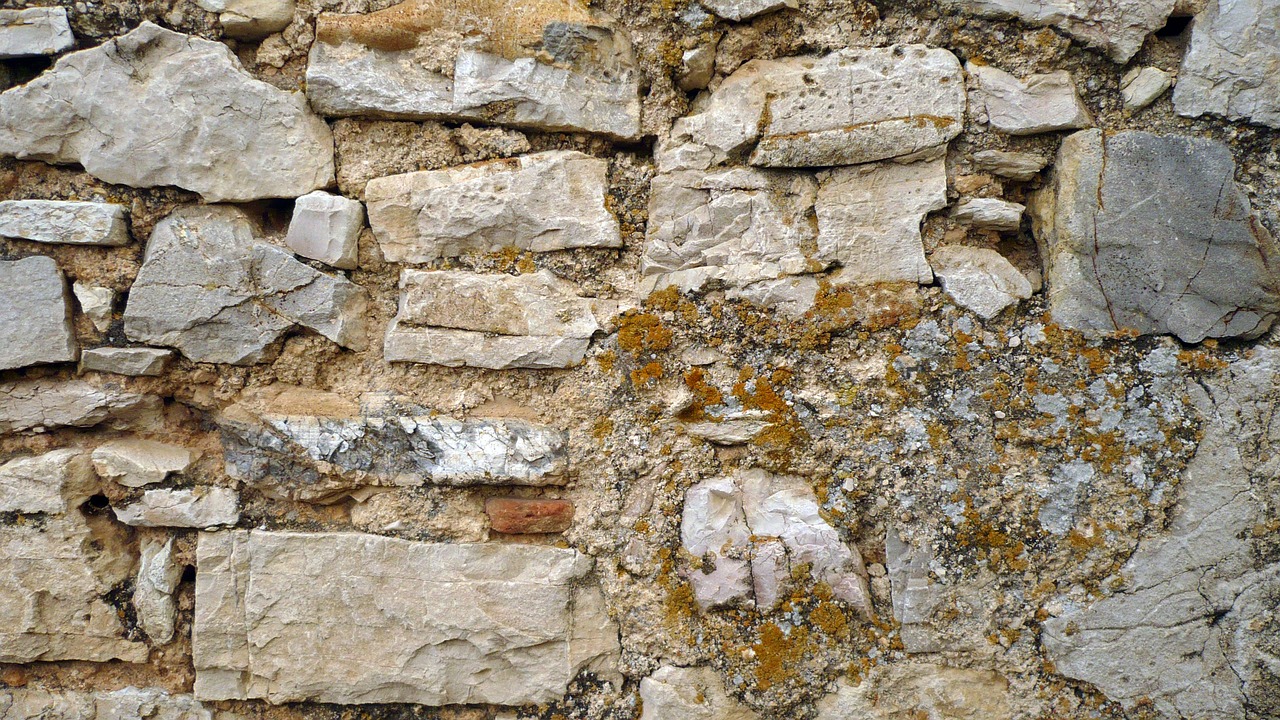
[814,158,947,284]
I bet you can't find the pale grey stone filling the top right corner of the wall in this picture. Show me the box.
[1174,0,1280,128]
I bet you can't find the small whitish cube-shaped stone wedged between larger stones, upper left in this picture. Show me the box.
[284,190,365,270]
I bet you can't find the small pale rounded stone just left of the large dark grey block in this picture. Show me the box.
[929,245,1032,319]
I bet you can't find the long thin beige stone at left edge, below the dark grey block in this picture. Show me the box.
[0,379,163,433]
